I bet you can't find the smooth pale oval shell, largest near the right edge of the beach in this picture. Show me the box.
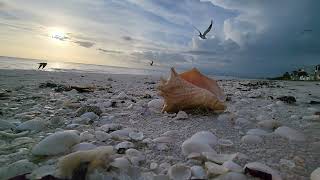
[274,126,306,141]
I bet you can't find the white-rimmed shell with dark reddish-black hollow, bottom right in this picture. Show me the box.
[244,162,281,180]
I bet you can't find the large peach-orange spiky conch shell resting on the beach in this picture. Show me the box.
[158,68,226,112]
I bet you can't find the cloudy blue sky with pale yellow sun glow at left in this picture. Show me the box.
[0,0,320,77]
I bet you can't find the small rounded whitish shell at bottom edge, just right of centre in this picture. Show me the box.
[168,164,191,180]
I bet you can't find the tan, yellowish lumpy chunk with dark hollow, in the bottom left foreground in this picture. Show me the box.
[58,146,115,178]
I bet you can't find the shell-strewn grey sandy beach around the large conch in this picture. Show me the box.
[0,69,320,180]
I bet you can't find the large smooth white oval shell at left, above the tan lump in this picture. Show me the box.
[32,130,80,156]
